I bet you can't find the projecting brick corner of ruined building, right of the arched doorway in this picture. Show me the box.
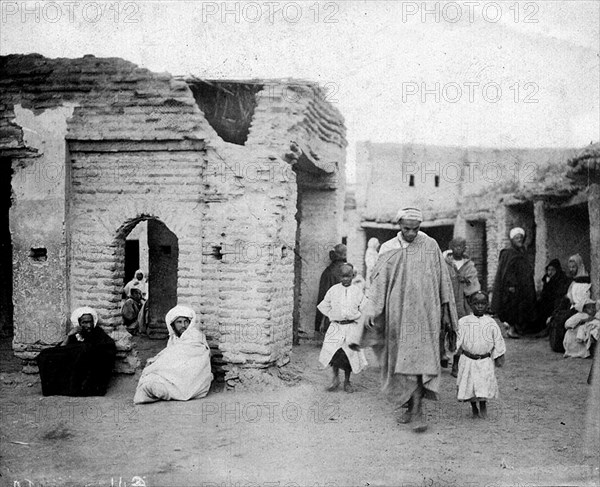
[197,80,344,376]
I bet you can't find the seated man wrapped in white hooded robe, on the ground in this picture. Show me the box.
[133,306,213,404]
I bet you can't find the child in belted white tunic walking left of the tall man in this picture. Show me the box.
[317,264,367,392]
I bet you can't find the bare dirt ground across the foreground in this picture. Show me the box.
[0,339,600,487]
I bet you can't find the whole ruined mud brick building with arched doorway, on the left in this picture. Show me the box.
[0,55,346,379]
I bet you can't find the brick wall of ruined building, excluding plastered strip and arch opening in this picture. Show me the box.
[0,55,346,379]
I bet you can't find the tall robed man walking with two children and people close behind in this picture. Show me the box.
[317,208,506,431]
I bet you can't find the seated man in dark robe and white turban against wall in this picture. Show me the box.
[37,306,117,396]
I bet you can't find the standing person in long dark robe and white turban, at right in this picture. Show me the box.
[492,227,536,338]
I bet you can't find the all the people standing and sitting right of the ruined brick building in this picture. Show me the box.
[315,212,600,431]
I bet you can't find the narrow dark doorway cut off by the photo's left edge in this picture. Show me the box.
[0,157,13,337]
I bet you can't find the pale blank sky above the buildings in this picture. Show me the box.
[0,0,600,178]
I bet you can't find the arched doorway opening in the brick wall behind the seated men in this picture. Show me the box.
[123,219,179,339]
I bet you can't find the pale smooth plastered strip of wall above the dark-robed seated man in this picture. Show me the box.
[10,105,73,371]
